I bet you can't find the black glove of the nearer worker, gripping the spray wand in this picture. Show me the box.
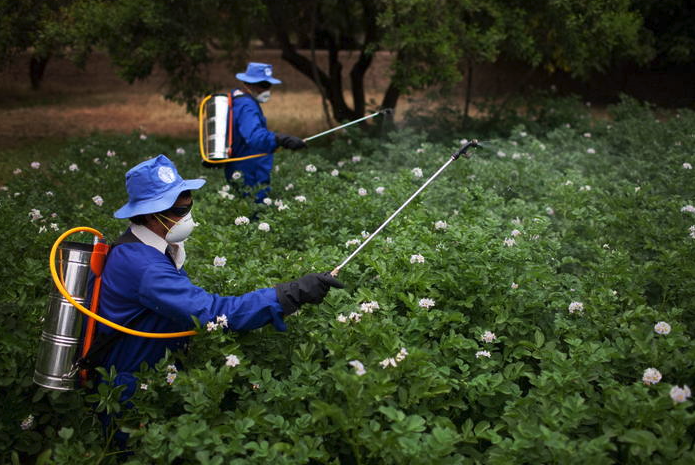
[275,273,345,315]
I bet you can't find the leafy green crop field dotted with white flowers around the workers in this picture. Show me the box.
[0,96,695,465]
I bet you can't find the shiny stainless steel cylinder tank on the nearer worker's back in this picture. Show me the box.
[34,242,93,391]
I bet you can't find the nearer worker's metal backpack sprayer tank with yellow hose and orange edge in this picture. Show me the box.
[34,227,197,391]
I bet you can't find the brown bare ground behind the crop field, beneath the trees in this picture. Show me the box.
[0,50,407,150]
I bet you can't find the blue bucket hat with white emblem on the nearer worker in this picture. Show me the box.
[113,155,205,219]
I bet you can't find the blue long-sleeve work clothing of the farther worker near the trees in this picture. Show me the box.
[225,89,277,190]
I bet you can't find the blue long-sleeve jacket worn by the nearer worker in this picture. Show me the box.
[99,234,286,398]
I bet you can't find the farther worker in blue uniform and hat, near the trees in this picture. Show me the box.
[225,62,306,202]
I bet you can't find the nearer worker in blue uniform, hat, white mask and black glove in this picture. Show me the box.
[97,155,343,399]
